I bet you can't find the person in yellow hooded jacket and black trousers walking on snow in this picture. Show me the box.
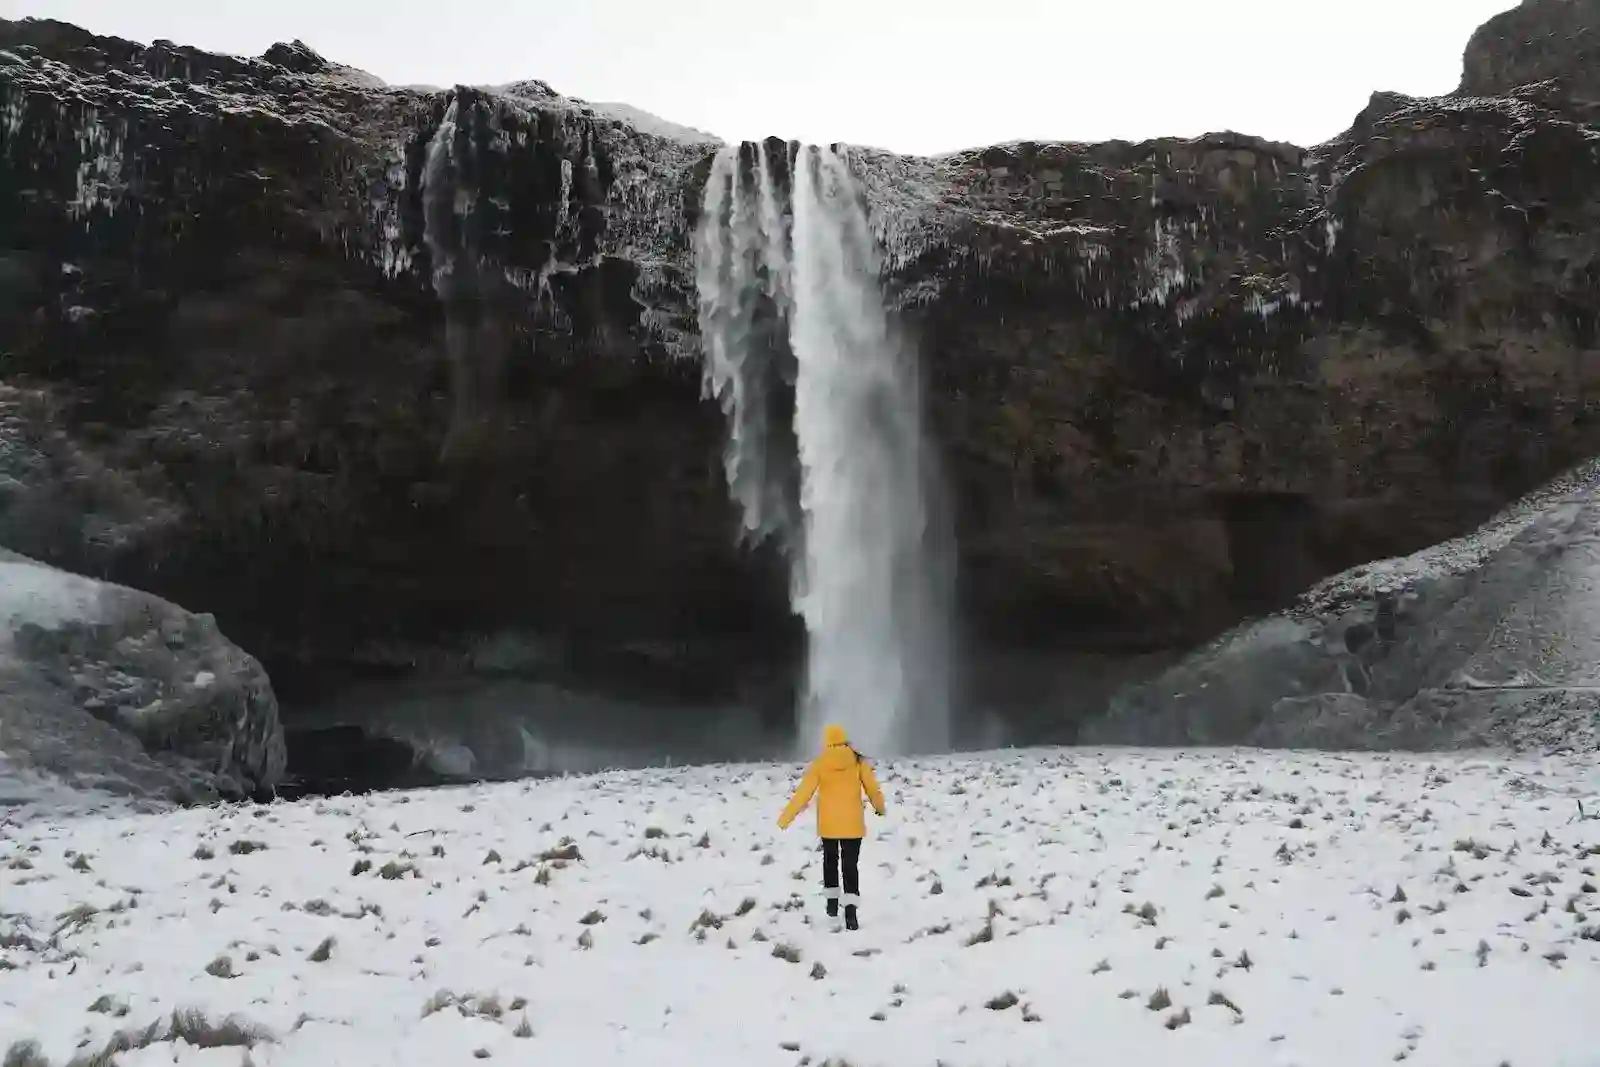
[778,726,883,929]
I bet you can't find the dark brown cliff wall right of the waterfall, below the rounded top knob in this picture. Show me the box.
[876,98,1600,643]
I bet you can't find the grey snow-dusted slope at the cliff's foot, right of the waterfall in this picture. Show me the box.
[1085,462,1600,752]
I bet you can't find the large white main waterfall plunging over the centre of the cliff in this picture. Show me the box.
[696,142,950,755]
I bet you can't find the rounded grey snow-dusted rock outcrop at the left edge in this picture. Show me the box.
[0,550,285,801]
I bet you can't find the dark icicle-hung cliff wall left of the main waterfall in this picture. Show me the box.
[0,22,786,703]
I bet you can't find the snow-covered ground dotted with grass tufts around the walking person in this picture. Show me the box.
[0,750,1600,1067]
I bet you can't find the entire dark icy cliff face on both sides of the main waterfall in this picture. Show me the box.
[0,0,1600,735]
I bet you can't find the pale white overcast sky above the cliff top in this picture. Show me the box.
[0,0,1515,152]
